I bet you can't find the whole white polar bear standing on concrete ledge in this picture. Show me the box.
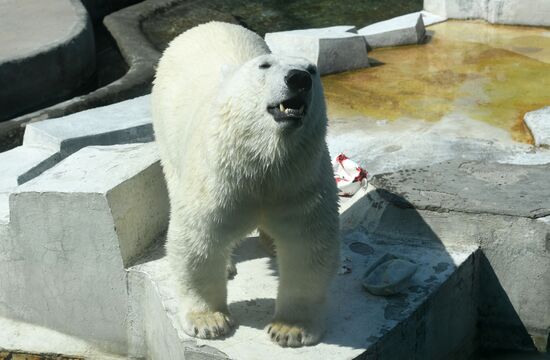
[152,22,339,347]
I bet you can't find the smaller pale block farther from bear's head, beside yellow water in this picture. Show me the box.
[357,13,426,48]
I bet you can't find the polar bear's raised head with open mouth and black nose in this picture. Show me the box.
[218,54,327,141]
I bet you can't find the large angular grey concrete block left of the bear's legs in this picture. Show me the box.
[0,143,168,354]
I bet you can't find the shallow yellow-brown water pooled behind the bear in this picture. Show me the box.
[323,21,550,142]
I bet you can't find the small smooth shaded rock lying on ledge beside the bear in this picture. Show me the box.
[362,254,418,296]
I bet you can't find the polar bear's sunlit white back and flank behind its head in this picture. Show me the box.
[152,22,269,170]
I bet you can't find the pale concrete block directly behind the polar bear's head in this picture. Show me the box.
[265,26,369,75]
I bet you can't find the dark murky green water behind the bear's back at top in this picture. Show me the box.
[142,0,422,50]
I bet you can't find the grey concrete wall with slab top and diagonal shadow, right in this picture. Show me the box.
[366,161,550,350]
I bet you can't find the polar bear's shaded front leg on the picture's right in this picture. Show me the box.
[266,200,339,347]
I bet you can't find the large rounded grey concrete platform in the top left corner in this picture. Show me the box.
[0,0,95,121]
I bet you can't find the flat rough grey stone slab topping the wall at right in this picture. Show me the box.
[371,160,550,218]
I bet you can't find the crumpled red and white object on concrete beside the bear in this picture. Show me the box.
[332,154,368,196]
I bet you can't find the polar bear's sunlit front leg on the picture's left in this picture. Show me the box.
[166,213,238,339]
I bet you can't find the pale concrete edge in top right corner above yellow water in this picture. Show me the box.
[424,0,550,26]
